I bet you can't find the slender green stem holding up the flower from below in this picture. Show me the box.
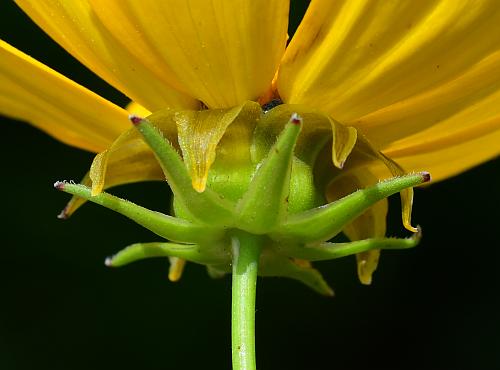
[231,231,262,370]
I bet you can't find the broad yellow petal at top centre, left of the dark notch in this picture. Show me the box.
[91,0,289,108]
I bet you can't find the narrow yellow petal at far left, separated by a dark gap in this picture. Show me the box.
[0,40,129,152]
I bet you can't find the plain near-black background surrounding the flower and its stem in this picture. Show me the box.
[0,2,500,370]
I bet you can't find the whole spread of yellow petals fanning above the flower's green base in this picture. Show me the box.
[0,0,500,282]
